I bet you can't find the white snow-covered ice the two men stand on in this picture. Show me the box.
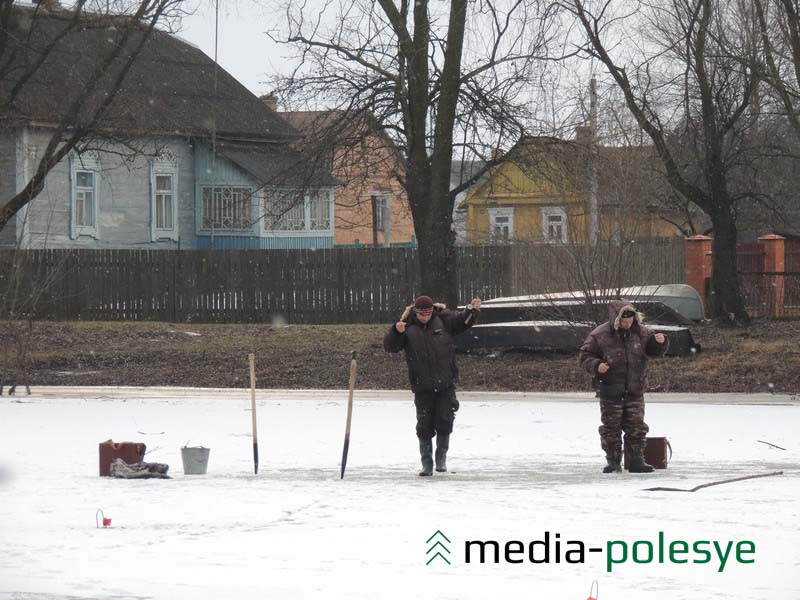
[0,388,800,600]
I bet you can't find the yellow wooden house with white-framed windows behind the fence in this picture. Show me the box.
[462,128,682,244]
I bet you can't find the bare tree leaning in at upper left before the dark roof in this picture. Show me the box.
[0,0,185,230]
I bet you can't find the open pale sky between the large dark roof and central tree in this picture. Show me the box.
[178,0,291,96]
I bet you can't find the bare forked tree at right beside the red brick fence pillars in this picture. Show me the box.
[570,0,759,322]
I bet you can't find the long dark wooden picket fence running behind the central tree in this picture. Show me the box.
[0,239,685,323]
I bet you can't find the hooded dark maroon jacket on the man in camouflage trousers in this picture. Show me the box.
[579,300,669,399]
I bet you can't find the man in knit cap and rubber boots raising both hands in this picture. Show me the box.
[383,296,481,476]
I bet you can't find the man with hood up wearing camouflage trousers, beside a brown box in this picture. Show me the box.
[579,300,669,473]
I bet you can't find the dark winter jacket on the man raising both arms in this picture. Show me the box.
[383,304,478,392]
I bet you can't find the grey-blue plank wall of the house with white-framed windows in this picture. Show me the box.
[0,127,335,249]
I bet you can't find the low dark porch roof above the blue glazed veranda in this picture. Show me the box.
[216,142,339,188]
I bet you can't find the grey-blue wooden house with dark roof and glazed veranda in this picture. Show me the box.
[0,6,337,249]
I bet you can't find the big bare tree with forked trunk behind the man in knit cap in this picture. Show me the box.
[273,0,560,303]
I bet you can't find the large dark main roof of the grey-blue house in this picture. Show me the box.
[0,7,297,139]
